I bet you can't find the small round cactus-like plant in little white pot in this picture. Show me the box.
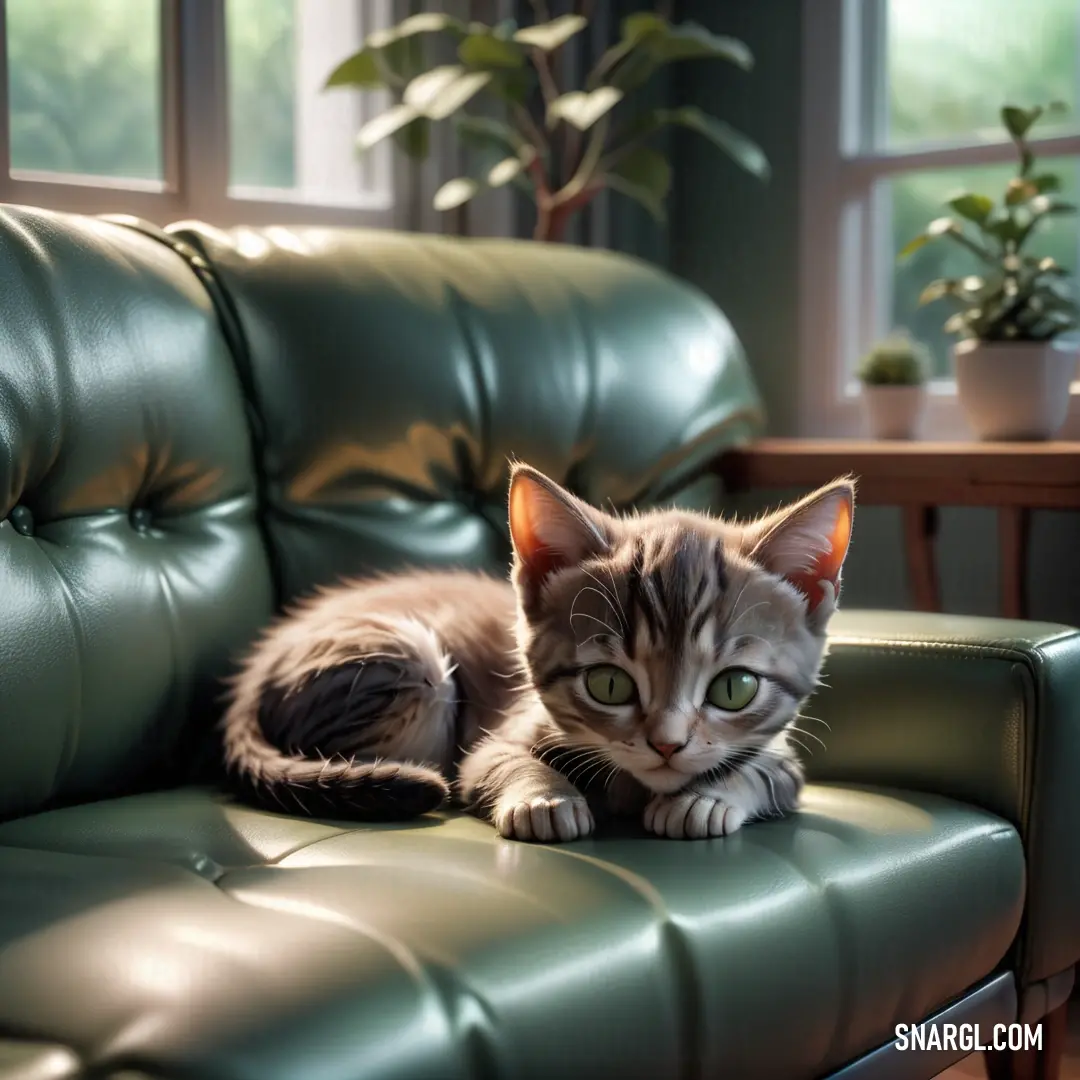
[858,333,930,438]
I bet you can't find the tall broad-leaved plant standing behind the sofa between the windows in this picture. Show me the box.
[326,0,769,240]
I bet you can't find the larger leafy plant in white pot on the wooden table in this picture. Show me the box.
[901,105,1078,440]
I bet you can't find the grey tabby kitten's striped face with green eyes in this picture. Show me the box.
[511,469,851,793]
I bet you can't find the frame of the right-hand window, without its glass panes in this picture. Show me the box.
[797,0,1080,441]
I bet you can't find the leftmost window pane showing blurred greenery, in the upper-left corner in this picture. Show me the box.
[6,0,162,180]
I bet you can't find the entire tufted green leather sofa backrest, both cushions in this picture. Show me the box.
[0,207,760,819]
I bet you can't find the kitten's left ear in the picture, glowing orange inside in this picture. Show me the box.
[510,464,608,583]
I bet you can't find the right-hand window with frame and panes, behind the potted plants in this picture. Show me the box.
[800,0,1080,438]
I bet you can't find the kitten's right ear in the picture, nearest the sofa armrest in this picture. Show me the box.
[751,480,855,612]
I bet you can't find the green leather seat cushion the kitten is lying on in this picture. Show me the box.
[0,785,1024,1080]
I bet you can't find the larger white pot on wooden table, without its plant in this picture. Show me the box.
[953,341,1077,441]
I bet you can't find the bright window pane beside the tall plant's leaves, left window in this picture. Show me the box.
[226,0,389,205]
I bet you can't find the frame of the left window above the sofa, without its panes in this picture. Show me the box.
[0,0,429,231]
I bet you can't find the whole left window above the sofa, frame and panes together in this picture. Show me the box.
[0,0,404,226]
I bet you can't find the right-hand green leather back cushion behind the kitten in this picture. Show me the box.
[170,224,760,599]
